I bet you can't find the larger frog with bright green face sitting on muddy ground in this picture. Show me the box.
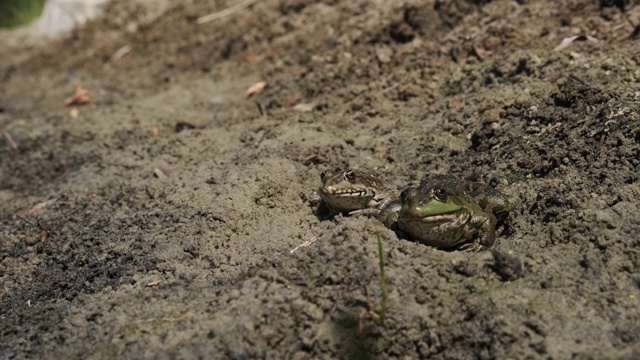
[397,175,512,251]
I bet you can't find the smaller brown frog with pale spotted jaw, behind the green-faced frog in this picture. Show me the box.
[318,170,400,215]
